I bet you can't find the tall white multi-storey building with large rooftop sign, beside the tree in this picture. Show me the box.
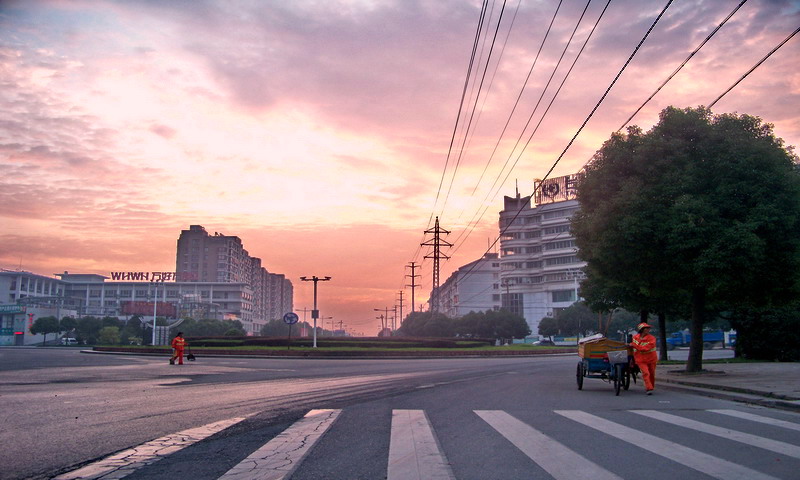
[500,175,586,335]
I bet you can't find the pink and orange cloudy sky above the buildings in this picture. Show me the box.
[0,0,800,335]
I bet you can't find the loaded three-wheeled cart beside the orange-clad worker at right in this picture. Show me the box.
[576,335,636,395]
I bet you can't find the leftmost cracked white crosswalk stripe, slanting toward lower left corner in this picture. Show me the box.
[53,417,247,480]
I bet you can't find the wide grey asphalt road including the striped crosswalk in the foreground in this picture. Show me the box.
[0,349,800,480]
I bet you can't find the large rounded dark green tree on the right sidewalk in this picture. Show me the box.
[572,107,800,371]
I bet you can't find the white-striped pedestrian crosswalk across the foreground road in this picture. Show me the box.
[55,409,800,480]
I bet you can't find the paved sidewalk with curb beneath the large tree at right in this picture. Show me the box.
[656,362,800,411]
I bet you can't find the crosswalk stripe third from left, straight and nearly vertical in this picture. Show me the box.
[386,410,455,480]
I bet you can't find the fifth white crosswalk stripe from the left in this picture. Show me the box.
[555,410,777,480]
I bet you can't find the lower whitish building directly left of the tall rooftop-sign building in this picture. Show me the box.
[431,253,502,318]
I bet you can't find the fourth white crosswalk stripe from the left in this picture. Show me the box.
[475,410,622,480]
